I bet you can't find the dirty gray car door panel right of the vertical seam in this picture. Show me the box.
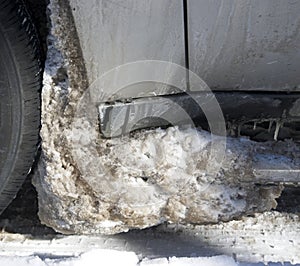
[188,0,300,91]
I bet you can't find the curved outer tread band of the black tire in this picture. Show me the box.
[0,0,43,214]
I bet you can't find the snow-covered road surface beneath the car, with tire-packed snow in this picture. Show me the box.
[0,212,300,266]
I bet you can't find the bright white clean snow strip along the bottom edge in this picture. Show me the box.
[0,249,291,266]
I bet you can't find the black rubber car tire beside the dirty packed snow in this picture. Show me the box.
[0,0,42,213]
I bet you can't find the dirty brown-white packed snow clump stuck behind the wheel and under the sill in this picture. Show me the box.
[34,0,294,234]
